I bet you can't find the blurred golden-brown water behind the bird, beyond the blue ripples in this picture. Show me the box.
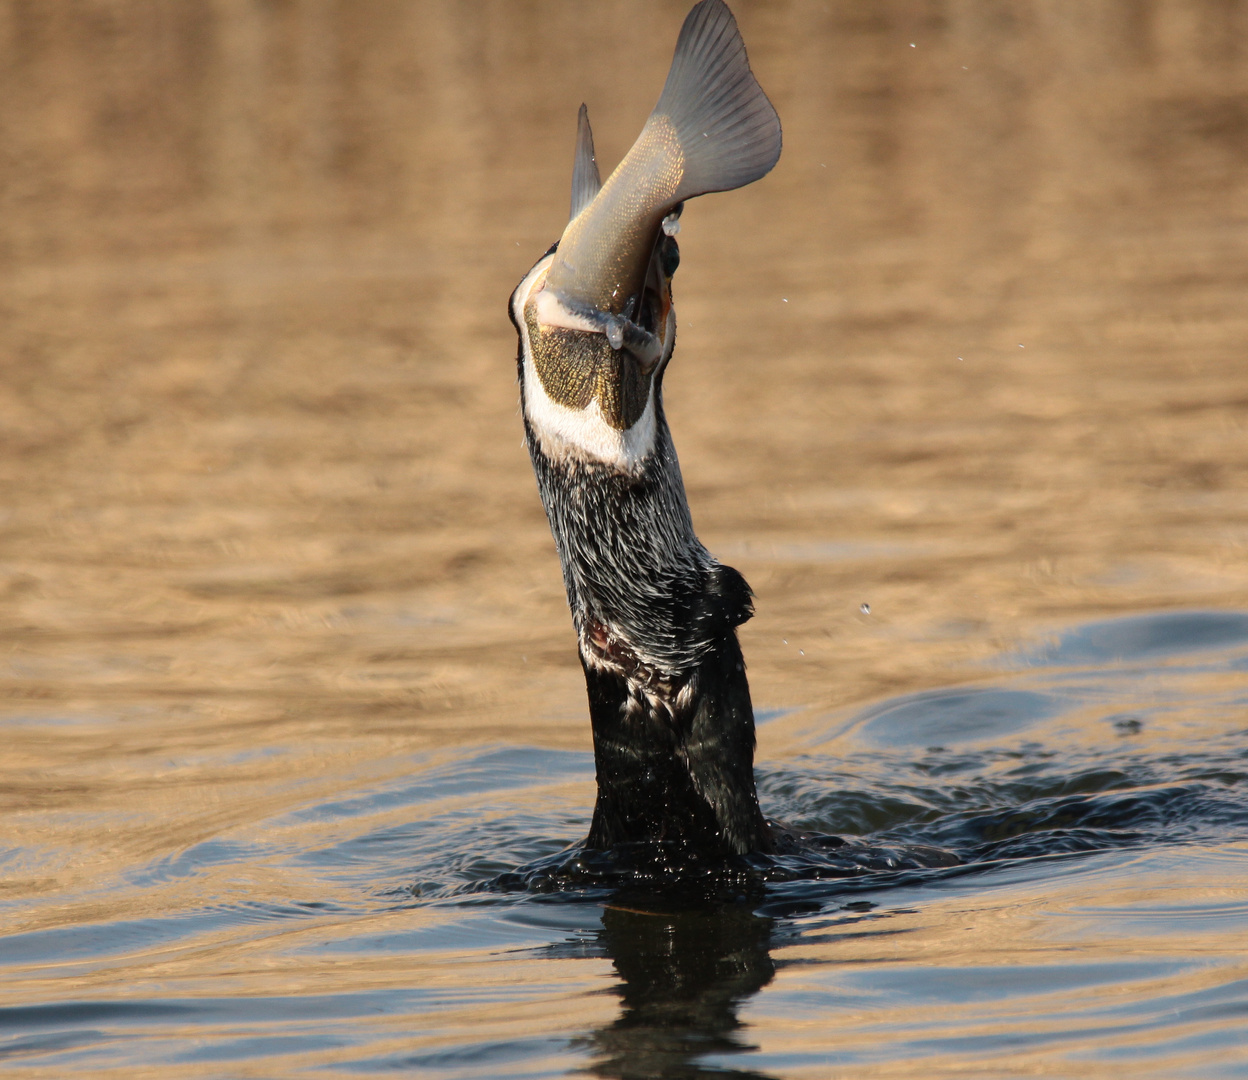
[0,0,1248,779]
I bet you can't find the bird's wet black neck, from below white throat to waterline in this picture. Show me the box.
[527,406,770,857]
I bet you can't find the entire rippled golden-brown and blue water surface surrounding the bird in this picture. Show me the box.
[0,0,1248,1080]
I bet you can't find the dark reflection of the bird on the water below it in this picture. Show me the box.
[582,905,775,1080]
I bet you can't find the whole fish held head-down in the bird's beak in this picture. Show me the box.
[515,0,782,431]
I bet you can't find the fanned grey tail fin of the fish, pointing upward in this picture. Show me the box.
[654,0,781,199]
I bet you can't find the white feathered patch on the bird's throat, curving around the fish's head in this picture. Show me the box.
[512,256,655,473]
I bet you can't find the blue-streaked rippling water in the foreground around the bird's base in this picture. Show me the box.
[7,613,1248,1076]
